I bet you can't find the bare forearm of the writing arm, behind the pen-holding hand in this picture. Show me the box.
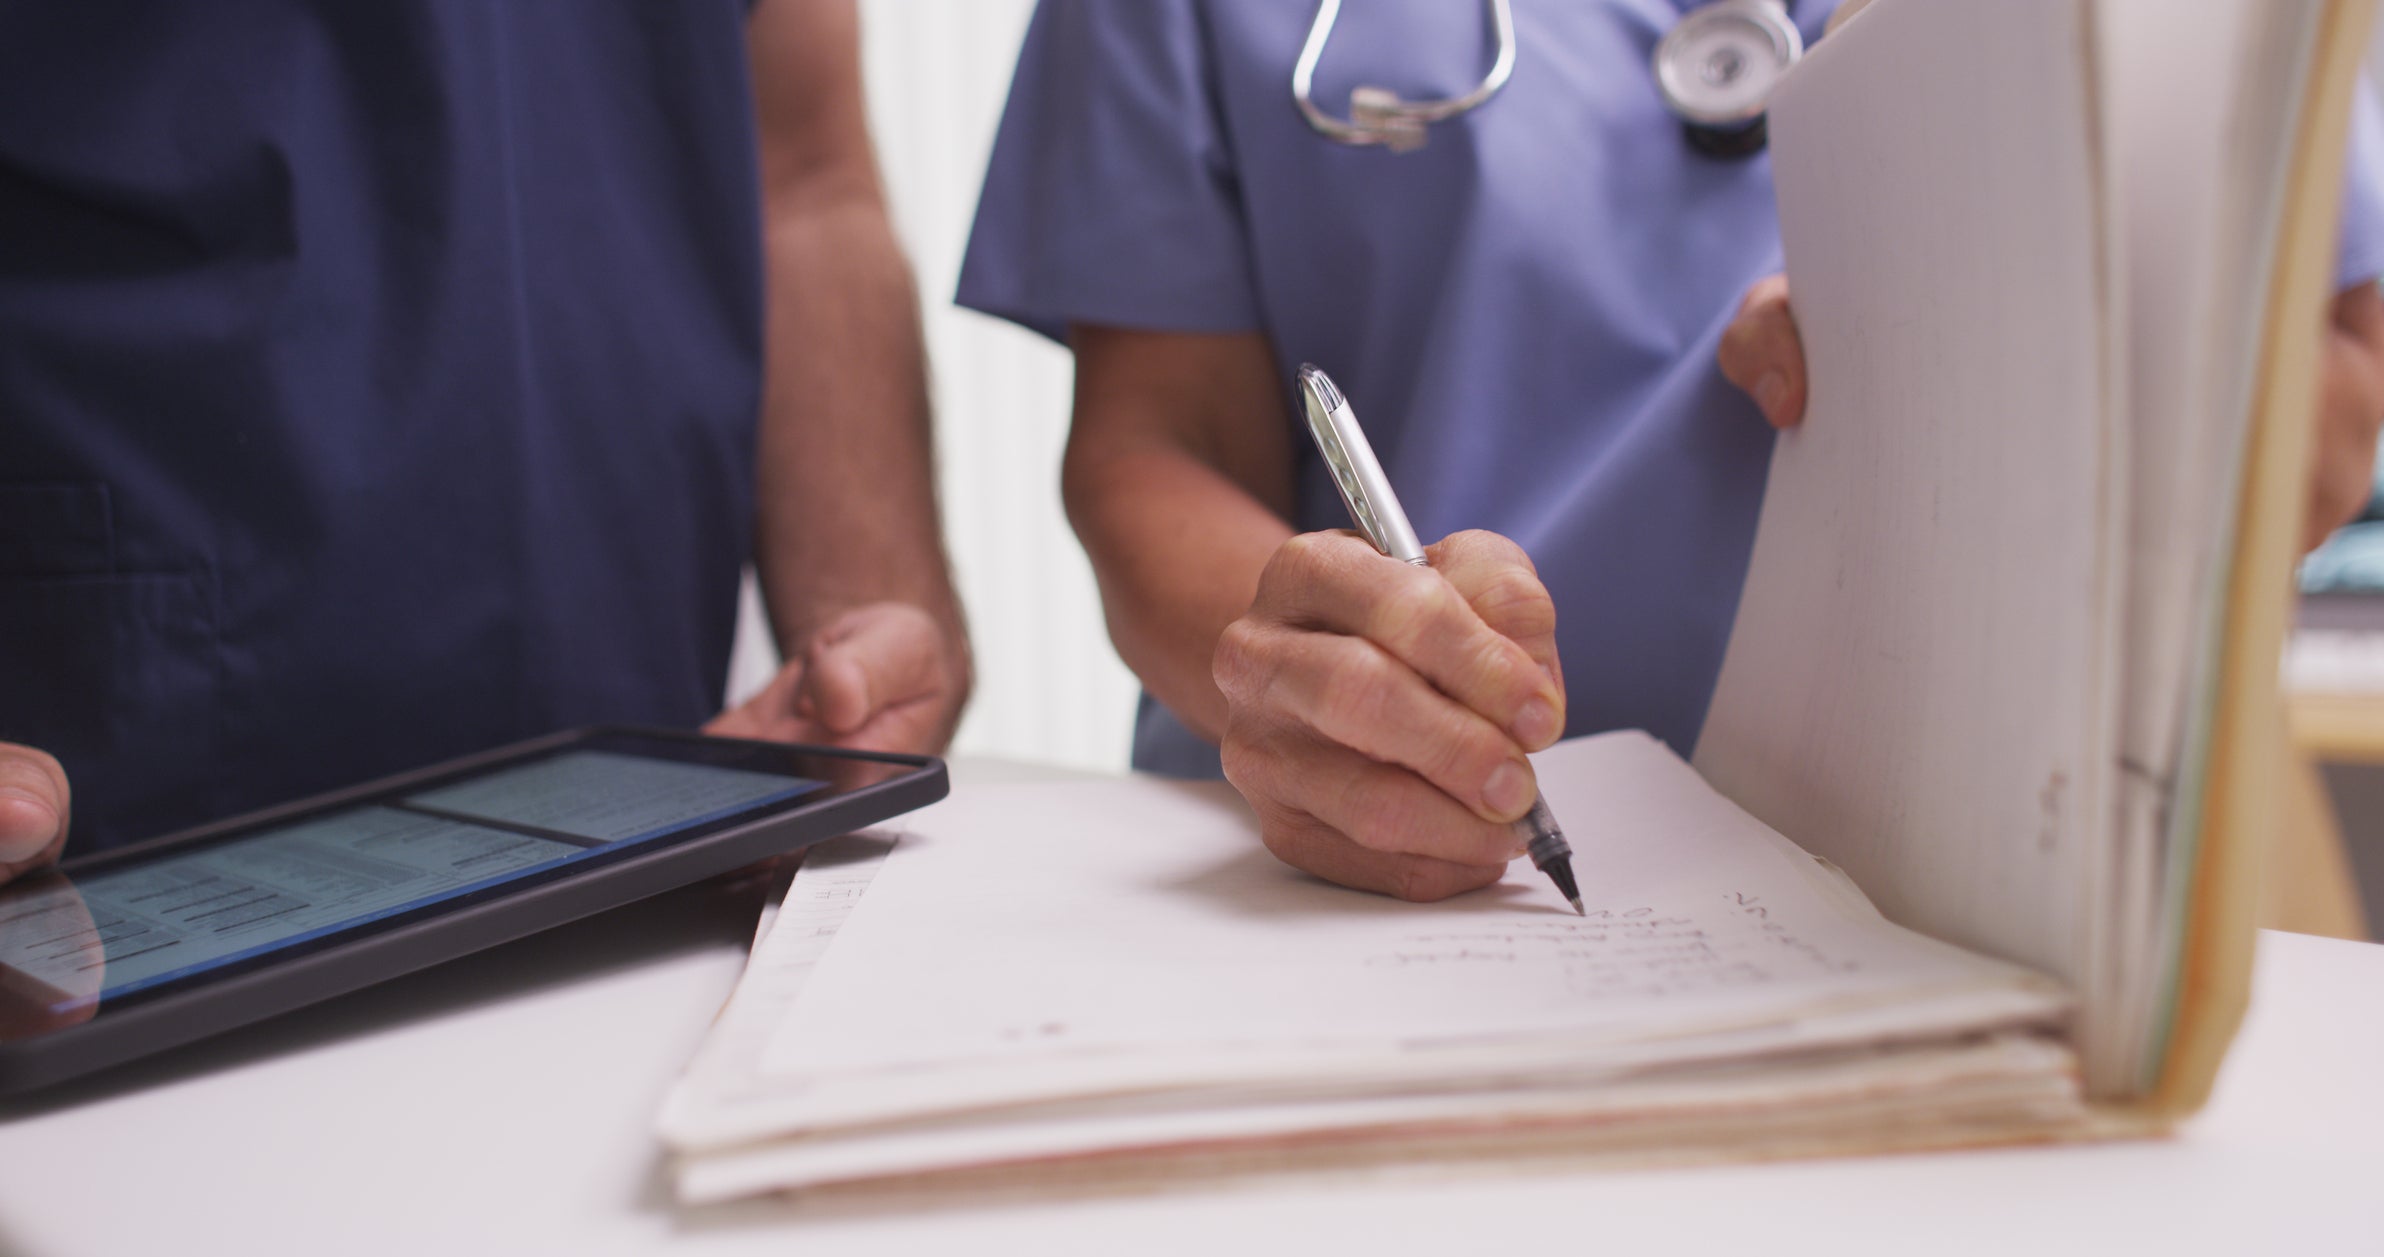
[1066,446,1292,742]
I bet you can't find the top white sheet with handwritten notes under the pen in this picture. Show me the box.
[729,735,2065,1126]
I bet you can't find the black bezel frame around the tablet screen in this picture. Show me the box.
[0,725,949,1095]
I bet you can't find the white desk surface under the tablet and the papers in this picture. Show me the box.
[0,772,2384,1257]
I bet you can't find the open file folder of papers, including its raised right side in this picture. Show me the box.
[663,0,2370,1200]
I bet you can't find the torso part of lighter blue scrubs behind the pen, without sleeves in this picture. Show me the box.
[1137,0,1833,770]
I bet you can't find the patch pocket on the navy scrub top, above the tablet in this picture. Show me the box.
[0,484,219,852]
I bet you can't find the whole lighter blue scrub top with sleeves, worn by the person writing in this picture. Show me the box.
[958,0,2384,775]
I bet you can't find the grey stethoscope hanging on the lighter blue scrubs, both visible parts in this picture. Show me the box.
[1292,0,1805,157]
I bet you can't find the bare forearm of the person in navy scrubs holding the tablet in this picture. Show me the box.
[756,205,966,675]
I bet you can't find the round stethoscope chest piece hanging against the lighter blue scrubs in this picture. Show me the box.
[1654,0,1805,157]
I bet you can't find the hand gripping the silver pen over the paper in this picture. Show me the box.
[1216,372,1571,899]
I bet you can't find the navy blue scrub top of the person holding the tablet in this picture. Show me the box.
[0,0,760,852]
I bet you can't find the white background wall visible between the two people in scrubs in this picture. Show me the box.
[730,0,1135,768]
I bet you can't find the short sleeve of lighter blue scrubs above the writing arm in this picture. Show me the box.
[958,0,1261,341]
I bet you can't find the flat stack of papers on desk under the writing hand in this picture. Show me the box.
[663,732,2081,1202]
